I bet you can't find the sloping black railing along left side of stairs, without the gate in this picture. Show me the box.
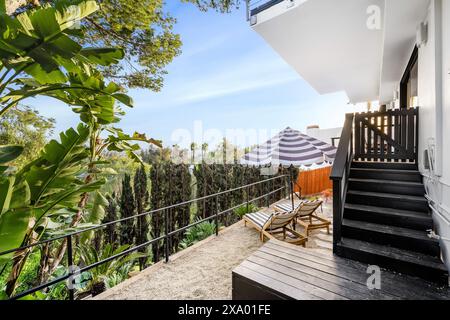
[330,113,355,252]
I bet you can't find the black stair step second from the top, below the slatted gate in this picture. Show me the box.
[350,168,423,182]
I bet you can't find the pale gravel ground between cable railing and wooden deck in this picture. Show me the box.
[95,198,332,300]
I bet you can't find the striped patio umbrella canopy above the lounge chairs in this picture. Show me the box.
[240,128,337,167]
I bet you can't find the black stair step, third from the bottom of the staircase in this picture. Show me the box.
[344,203,433,230]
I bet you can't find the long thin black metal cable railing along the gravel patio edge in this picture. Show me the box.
[0,175,293,300]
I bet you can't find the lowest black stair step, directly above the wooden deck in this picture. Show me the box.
[336,238,448,286]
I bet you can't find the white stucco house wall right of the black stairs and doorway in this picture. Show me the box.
[419,0,450,268]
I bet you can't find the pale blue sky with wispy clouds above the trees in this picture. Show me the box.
[28,1,366,146]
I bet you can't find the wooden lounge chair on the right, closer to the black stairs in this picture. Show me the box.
[275,200,331,237]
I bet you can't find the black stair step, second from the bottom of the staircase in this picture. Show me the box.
[342,219,440,257]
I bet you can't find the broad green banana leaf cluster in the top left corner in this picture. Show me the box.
[0,0,124,84]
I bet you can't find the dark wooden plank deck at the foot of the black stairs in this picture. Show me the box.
[233,240,450,300]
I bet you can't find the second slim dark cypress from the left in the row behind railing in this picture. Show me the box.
[120,174,136,245]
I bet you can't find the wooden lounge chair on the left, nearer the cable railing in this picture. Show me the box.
[244,212,308,246]
